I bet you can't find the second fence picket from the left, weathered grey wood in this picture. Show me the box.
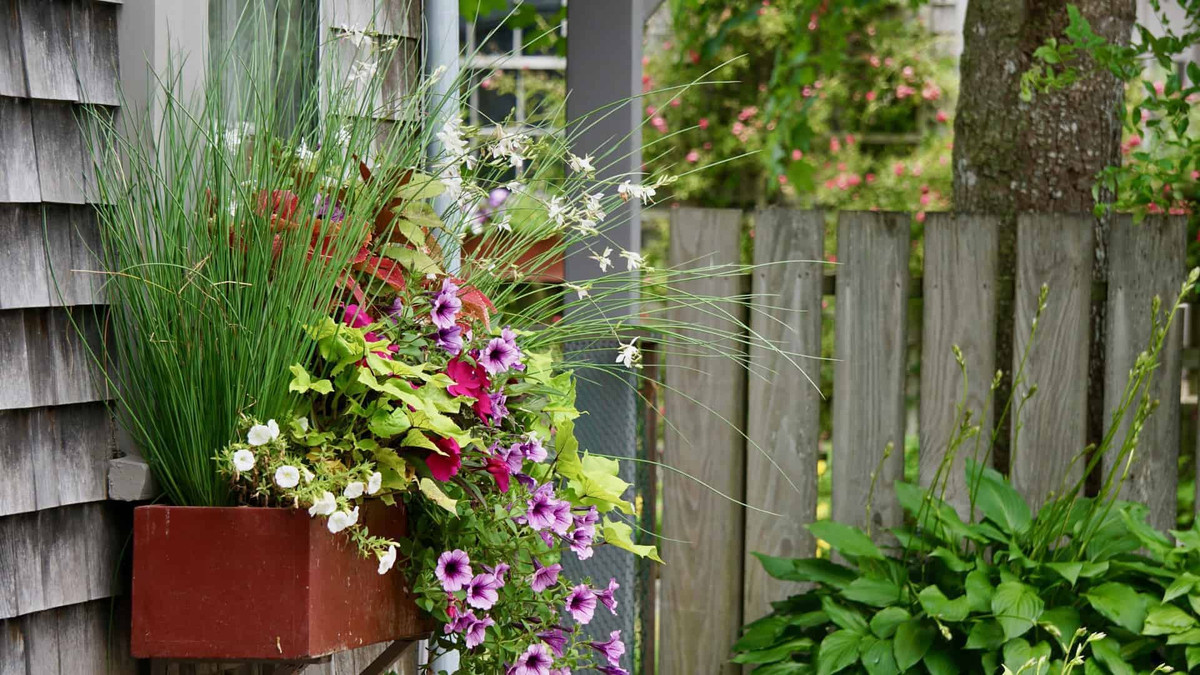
[742,209,824,621]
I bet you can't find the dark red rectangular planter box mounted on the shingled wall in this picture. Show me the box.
[132,501,432,661]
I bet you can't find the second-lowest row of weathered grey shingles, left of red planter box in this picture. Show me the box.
[0,502,125,619]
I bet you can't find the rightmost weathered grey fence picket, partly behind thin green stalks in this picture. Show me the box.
[1102,216,1187,531]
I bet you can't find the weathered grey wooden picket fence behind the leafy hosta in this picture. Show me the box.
[650,208,1186,675]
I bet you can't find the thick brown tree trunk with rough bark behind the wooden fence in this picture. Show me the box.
[954,0,1136,470]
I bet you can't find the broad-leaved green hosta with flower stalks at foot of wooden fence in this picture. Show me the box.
[733,270,1200,675]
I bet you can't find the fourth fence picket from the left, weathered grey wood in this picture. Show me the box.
[920,214,1000,515]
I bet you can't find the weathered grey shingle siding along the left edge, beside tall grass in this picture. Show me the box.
[0,0,136,675]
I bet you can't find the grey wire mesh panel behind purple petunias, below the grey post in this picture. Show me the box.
[563,340,641,665]
